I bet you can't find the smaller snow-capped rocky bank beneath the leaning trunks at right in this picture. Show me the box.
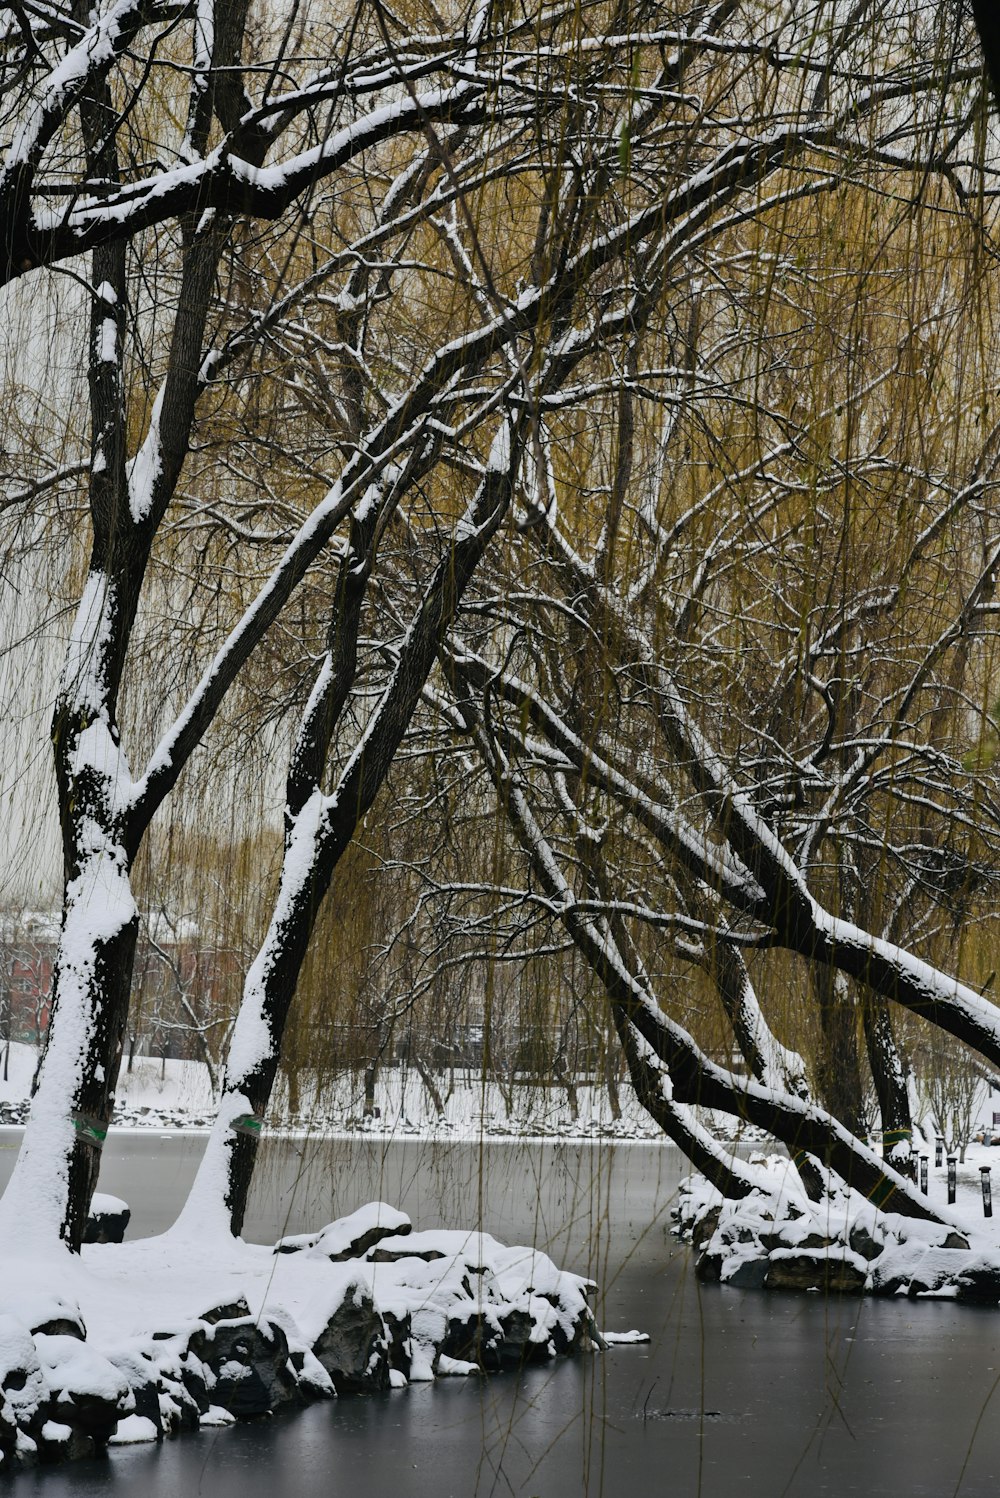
[674,1155,1000,1305]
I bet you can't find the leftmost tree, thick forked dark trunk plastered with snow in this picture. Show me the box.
[0,3,539,1245]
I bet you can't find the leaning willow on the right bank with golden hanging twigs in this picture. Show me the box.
[392,23,1000,1215]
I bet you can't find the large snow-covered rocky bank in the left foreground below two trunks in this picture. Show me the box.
[0,1201,603,1468]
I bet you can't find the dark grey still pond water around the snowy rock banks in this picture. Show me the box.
[0,1135,1000,1498]
